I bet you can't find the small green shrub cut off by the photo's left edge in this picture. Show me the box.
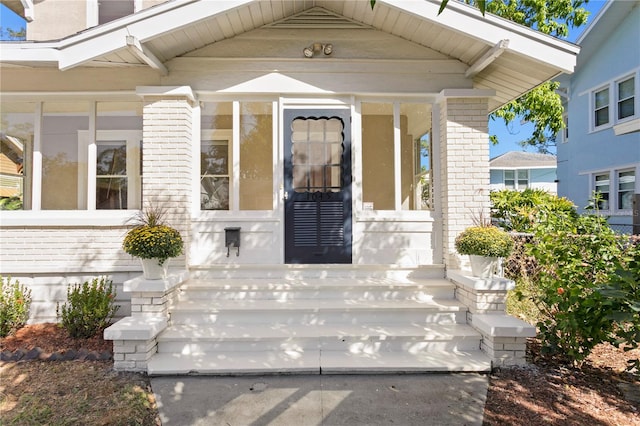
[0,276,31,337]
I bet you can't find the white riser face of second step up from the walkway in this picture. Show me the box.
[158,337,480,356]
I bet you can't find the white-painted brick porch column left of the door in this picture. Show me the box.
[137,86,200,267]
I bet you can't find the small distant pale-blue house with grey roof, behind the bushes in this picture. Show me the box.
[489,151,557,194]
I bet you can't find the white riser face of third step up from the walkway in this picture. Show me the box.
[171,309,466,325]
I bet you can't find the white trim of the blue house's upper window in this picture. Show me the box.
[580,68,640,135]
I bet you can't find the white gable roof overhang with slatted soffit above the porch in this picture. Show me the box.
[0,0,579,109]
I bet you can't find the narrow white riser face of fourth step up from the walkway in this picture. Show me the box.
[179,287,454,301]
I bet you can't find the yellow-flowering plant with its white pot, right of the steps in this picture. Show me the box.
[455,225,513,278]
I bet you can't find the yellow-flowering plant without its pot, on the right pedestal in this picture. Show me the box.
[455,226,513,257]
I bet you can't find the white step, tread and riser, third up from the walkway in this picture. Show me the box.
[166,299,467,325]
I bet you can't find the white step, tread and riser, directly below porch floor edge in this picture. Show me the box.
[179,277,455,301]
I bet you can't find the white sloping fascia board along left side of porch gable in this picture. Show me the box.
[59,0,253,70]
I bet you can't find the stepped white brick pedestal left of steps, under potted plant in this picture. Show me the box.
[104,270,189,372]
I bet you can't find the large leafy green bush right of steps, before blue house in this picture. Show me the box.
[530,208,627,363]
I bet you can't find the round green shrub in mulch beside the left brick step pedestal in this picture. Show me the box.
[56,277,120,339]
